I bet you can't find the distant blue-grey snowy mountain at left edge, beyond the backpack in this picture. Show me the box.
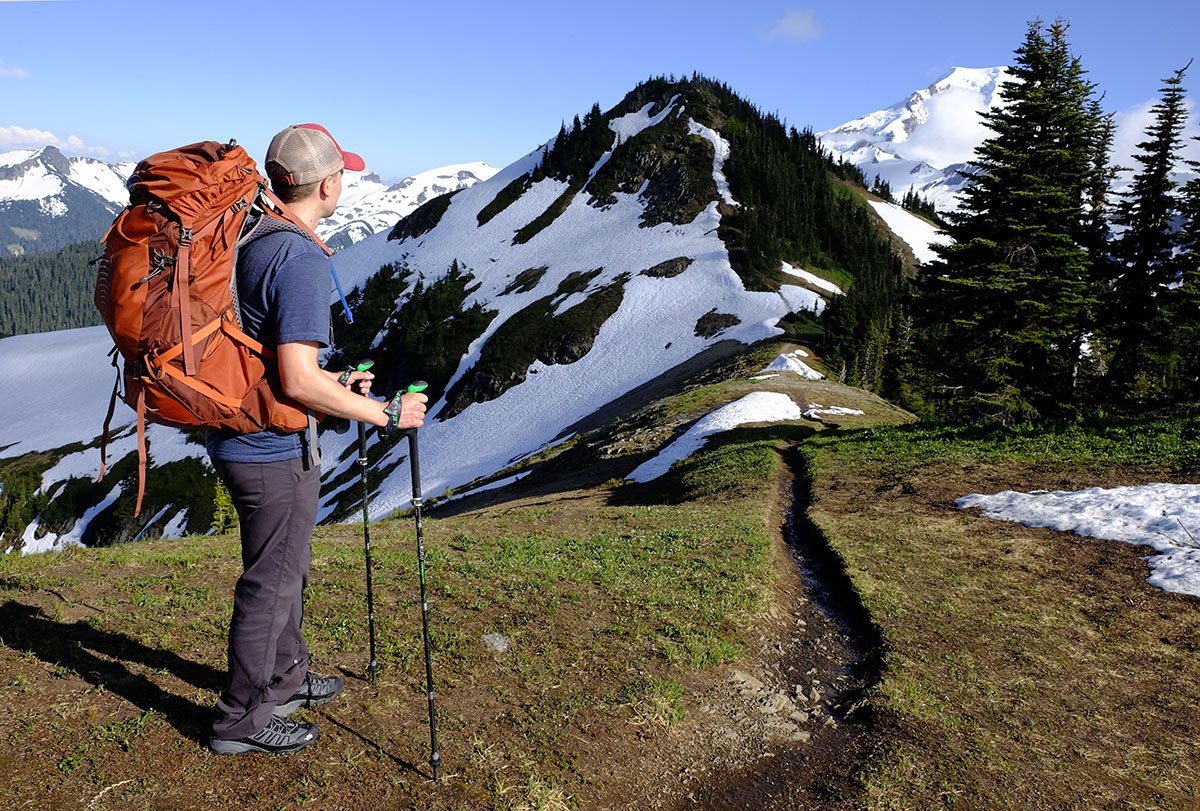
[0,146,133,256]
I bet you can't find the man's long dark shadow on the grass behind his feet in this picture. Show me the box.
[0,600,226,744]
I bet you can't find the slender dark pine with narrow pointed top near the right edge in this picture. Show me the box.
[1105,62,1190,403]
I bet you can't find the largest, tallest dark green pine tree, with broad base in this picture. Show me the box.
[922,20,1104,423]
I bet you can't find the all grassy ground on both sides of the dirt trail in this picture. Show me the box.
[0,338,1200,809]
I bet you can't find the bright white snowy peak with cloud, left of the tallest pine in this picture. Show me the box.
[817,67,1012,211]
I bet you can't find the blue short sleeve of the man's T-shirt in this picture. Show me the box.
[269,251,332,347]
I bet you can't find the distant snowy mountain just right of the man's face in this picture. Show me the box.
[317,161,498,250]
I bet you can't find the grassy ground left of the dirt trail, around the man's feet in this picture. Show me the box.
[0,347,816,809]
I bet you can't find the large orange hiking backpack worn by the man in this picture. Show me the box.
[95,140,332,515]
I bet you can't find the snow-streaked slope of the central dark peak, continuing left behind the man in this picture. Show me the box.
[0,79,928,551]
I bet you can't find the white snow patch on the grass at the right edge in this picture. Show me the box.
[955,483,1200,596]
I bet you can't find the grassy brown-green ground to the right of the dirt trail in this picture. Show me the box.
[805,421,1200,809]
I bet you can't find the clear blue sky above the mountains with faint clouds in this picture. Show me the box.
[0,0,1200,180]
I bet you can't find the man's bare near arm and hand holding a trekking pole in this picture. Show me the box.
[276,341,428,429]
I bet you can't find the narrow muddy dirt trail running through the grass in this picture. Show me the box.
[604,450,882,811]
